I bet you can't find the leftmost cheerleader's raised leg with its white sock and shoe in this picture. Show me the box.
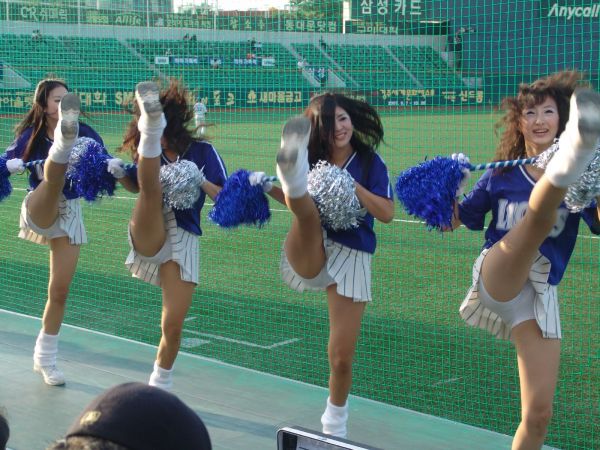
[27,93,80,228]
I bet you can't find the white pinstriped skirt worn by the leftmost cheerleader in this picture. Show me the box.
[19,192,87,245]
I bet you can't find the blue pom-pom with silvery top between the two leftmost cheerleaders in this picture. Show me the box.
[67,138,116,202]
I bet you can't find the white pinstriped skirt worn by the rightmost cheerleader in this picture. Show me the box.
[460,249,562,339]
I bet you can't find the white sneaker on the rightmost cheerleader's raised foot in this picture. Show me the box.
[565,89,600,149]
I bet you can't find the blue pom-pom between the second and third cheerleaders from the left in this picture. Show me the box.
[208,169,271,228]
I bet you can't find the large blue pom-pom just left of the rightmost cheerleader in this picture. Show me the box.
[396,156,463,230]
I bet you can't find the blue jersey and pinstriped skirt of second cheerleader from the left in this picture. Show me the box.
[125,141,227,286]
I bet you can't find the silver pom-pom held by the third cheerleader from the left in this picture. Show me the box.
[308,161,364,231]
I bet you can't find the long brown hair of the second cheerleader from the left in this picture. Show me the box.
[119,78,195,161]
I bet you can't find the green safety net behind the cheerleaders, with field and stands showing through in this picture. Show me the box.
[0,0,600,449]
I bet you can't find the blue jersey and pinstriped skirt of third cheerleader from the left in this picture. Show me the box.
[280,152,393,302]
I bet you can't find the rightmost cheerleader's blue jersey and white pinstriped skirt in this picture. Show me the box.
[458,166,600,339]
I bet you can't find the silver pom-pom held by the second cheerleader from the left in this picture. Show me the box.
[160,159,206,209]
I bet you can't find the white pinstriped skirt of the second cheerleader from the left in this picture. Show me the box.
[125,207,200,286]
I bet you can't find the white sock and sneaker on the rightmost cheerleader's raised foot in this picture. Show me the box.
[545,91,600,188]
